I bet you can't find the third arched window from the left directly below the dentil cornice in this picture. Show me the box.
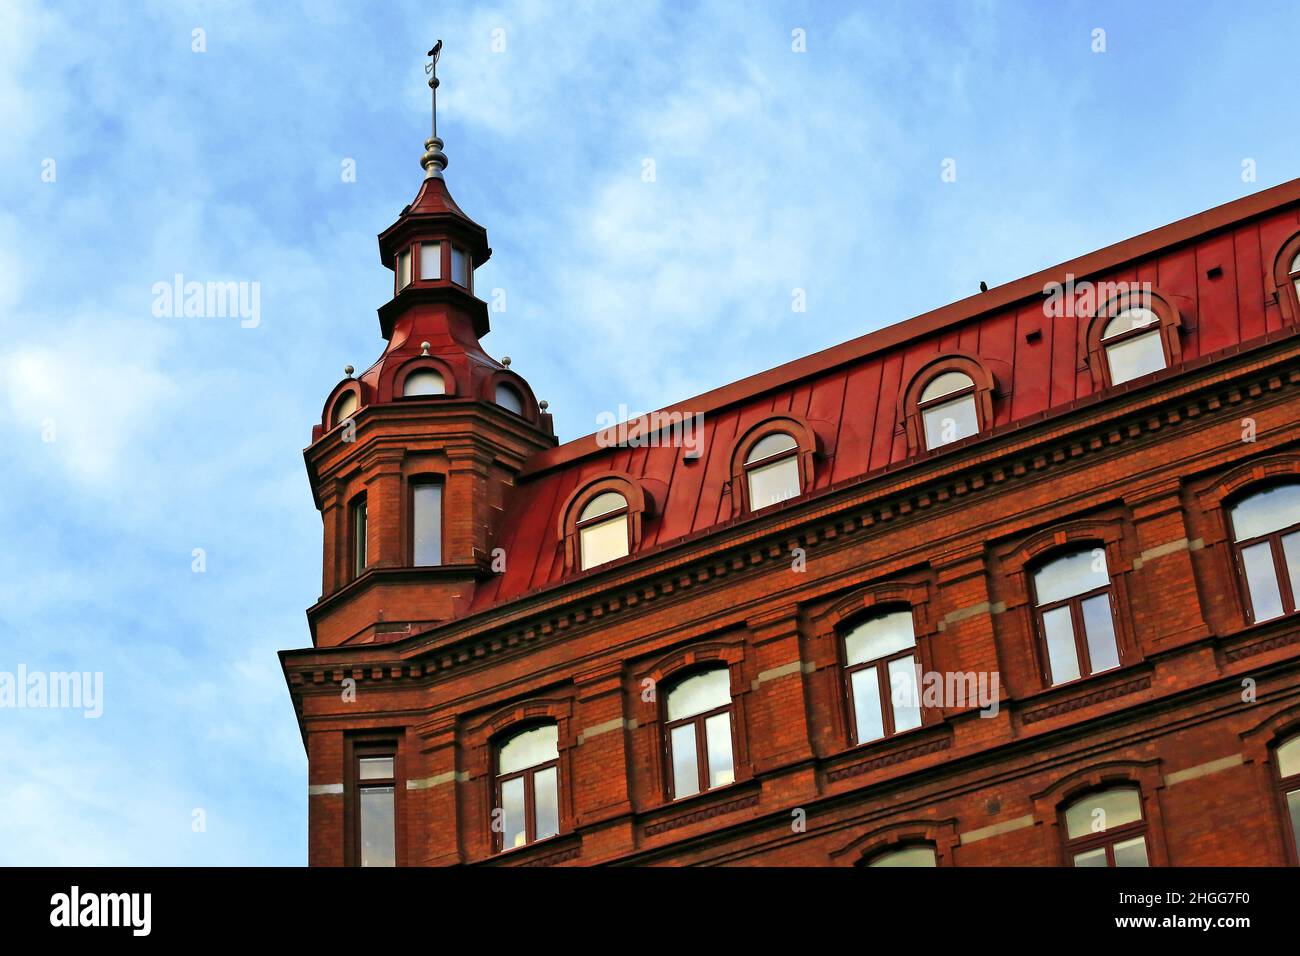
[844,609,920,744]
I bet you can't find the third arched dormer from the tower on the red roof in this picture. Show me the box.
[898,352,995,454]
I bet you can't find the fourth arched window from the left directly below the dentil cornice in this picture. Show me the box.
[1034,548,1119,684]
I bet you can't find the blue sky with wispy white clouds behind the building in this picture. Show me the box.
[0,0,1300,864]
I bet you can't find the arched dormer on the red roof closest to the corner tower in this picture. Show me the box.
[559,472,651,571]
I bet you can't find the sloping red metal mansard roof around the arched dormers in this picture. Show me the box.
[473,179,1300,610]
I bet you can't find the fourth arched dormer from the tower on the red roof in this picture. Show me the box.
[1083,287,1183,388]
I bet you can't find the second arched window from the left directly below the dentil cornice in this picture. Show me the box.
[664,667,736,800]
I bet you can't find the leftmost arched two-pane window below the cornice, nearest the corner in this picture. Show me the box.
[497,723,560,849]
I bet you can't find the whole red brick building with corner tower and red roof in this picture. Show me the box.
[282,91,1300,866]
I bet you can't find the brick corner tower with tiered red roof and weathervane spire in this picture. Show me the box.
[303,40,555,646]
